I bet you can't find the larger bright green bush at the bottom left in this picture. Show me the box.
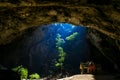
[12,65,28,80]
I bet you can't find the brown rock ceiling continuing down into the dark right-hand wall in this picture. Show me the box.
[0,1,120,72]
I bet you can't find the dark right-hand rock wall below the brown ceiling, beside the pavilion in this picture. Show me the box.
[88,29,120,72]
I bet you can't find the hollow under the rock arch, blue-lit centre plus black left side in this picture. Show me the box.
[1,23,90,76]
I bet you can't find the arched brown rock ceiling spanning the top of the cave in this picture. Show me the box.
[0,2,120,44]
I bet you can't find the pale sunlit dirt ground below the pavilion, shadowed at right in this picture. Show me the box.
[58,74,120,80]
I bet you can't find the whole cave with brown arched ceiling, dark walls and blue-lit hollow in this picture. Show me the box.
[0,0,120,77]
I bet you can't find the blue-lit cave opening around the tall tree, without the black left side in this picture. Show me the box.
[25,23,89,75]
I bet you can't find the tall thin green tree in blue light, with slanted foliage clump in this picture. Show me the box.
[55,32,78,74]
